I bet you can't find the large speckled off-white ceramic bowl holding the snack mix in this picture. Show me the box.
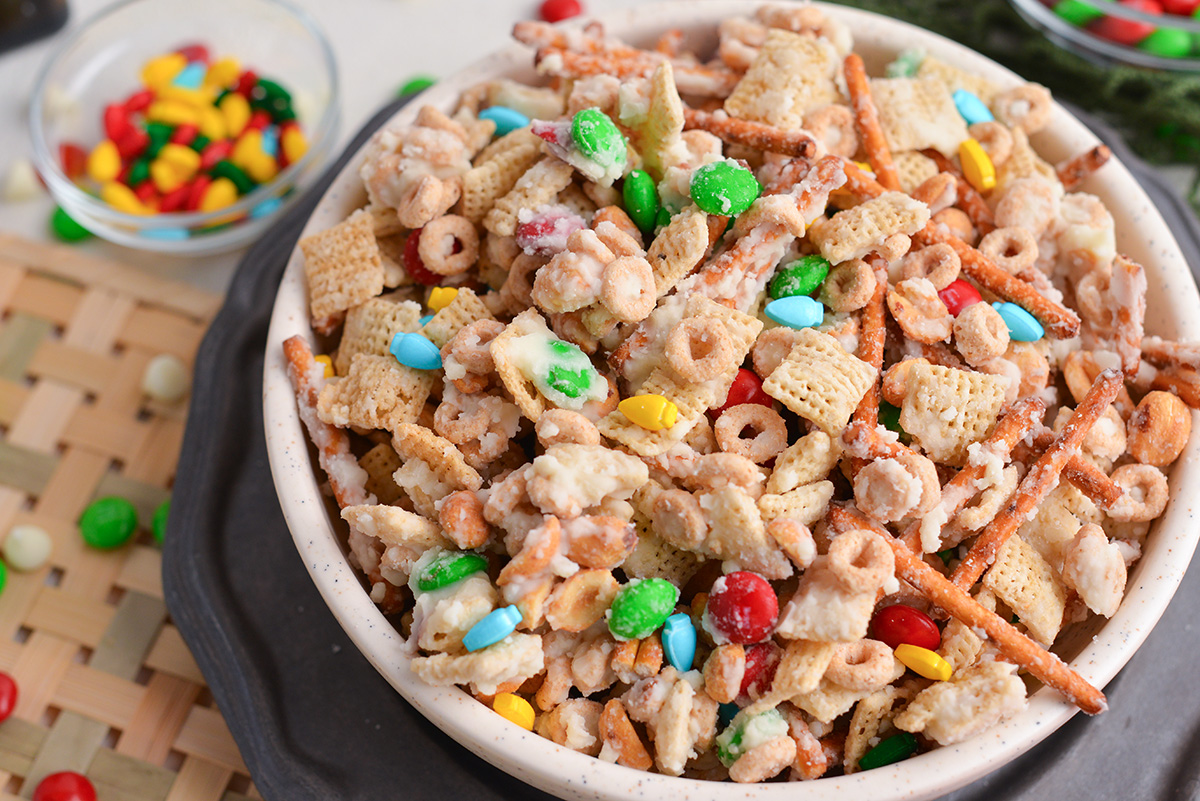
[263,0,1200,801]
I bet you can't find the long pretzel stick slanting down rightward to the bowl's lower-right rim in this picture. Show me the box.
[829,506,1109,715]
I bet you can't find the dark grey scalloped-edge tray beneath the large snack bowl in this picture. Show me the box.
[163,104,1200,801]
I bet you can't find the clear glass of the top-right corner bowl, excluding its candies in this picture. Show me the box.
[1010,0,1200,72]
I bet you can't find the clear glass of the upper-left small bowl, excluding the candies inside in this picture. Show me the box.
[30,0,338,255]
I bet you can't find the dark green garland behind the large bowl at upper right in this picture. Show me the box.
[834,0,1200,212]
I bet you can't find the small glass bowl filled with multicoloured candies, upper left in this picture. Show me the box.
[30,0,338,255]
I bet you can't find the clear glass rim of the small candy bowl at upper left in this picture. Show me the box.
[29,0,341,231]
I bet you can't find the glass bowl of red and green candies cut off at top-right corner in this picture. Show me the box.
[1012,0,1200,72]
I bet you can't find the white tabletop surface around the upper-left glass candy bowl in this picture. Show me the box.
[0,0,637,291]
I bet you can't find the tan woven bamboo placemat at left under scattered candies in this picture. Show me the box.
[0,235,260,801]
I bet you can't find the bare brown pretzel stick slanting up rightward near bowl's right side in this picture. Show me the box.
[950,369,1124,590]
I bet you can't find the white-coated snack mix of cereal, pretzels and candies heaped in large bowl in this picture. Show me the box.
[284,4,1200,782]
